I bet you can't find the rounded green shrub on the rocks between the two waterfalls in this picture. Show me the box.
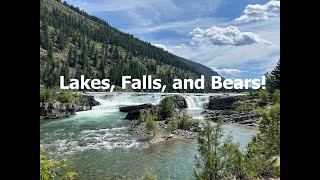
[158,97,175,119]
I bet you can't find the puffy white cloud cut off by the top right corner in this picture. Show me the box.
[235,0,280,23]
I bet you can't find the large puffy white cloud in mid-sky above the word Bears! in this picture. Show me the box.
[189,26,271,46]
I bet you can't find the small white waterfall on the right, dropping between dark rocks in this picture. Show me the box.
[183,94,209,109]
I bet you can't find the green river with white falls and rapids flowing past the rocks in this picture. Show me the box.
[40,93,256,179]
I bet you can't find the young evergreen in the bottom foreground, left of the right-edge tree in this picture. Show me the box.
[195,120,243,180]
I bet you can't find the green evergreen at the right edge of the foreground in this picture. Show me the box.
[247,103,280,178]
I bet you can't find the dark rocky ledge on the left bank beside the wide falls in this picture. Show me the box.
[40,95,100,120]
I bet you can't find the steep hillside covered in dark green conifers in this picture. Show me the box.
[40,0,219,92]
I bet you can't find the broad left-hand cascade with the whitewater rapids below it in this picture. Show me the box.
[42,93,162,154]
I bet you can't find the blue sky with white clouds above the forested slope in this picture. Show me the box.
[66,0,280,79]
